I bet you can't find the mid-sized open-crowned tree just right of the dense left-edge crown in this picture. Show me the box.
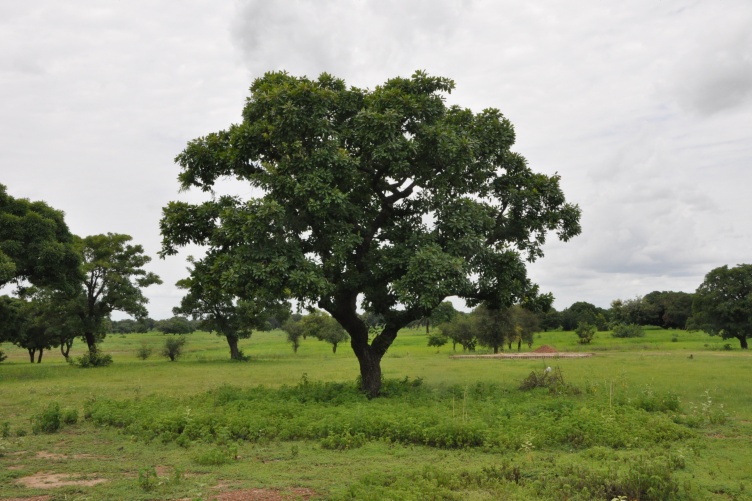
[75,233,162,353]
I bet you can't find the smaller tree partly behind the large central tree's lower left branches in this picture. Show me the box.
[172,258,290,360]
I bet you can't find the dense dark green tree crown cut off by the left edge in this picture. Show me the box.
[0,184,80,291]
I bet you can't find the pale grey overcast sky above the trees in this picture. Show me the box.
[0,0,752,318]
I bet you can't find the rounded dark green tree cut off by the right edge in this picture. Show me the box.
[692,264,752,350]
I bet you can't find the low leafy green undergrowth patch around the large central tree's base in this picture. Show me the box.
[84,379,693,451]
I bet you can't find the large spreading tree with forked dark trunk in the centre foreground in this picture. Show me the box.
[161,72,580,395]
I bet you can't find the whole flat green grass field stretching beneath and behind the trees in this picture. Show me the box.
[0,330,752,500]
